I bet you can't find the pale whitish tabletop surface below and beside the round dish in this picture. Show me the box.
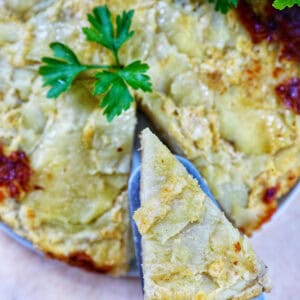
[0,193,300,300]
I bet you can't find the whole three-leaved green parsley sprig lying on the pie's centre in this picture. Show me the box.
[39,5,152,121]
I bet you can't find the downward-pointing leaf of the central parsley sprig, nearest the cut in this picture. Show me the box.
[94,71,134,121]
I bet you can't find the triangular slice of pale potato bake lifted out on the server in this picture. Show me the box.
[134,129,269,300]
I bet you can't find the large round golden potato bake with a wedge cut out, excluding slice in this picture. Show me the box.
[0,0,300,274]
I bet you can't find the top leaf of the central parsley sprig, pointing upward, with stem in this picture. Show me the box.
[82,5,134,65]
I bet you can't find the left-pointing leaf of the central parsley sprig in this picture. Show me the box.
[39,43,88,98]
